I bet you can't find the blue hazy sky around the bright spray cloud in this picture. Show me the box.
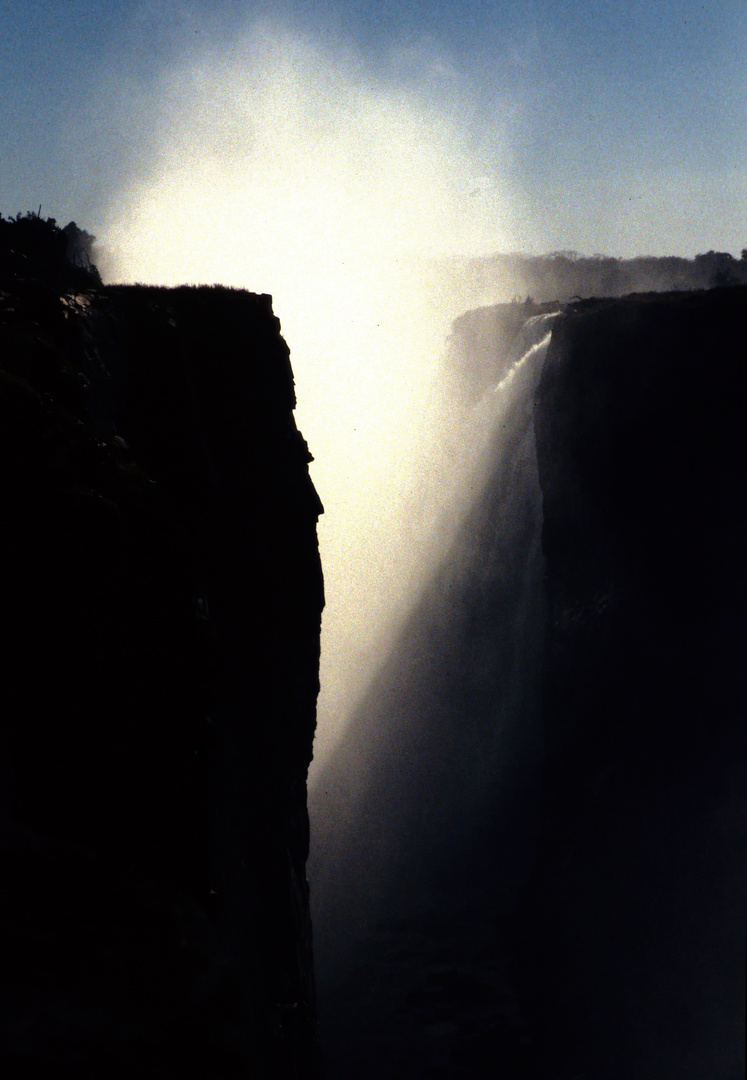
[0,0,747,255]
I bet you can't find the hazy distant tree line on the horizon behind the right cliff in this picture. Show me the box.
[467,248,747,302]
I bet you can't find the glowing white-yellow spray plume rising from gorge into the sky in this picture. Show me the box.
[99,16,528,783]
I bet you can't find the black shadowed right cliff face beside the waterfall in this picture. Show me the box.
[516,288,747,1080]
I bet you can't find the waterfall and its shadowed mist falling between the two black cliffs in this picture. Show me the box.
[309,314,554,1080]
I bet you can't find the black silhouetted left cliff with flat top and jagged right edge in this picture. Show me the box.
[0,282,323,1080]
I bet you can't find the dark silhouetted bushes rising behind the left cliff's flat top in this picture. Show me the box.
[0,210,101,288]
